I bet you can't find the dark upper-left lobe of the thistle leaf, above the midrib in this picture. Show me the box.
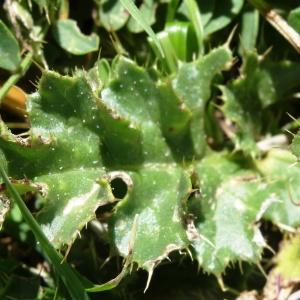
[0,72,102,179]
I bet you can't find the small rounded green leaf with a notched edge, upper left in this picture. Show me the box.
[53,19,99,55]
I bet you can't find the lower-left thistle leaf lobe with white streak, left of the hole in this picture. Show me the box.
[36,169,113,248]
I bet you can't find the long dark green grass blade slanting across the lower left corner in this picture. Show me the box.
[0,164,89,300]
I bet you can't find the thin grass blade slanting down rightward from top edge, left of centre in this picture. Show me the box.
[121,0,164,57]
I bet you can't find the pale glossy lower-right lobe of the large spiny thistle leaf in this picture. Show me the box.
[189,154,268,275]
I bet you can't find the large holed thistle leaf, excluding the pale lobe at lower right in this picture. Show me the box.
[0,47,231,272]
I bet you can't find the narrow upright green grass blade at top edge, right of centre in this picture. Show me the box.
[185,0,204,55]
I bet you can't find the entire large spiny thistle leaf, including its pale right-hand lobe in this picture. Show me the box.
[1,47,291,275]
